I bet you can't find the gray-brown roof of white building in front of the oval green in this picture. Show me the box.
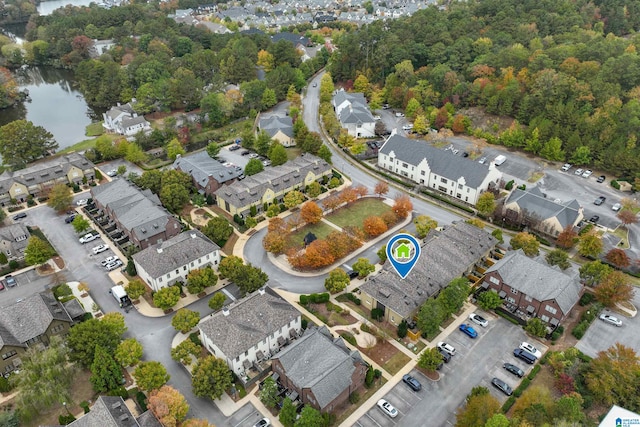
[198,287,300,359]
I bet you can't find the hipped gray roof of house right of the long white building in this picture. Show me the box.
[506,187,580,228]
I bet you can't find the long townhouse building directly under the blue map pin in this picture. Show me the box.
[360,221,498,325]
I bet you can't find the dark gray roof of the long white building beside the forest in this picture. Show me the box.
[379,134,496,188]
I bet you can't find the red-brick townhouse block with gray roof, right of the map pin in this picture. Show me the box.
[482,249,583,326]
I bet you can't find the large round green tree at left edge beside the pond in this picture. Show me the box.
[0,120,58,169]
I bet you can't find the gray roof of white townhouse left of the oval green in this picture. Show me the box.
[133,230,220,278]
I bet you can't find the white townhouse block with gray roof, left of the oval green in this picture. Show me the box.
[132,230,220,291]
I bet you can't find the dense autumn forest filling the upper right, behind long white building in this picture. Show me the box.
[329,0,640,177]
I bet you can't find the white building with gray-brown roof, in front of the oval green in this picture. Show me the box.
[198,287,302,380]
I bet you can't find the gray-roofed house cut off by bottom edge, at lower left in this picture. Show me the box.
[45,396,162,427]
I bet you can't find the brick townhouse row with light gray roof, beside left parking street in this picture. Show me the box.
[91,179,182,249]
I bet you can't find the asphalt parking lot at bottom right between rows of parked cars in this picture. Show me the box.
[355,313,546,427]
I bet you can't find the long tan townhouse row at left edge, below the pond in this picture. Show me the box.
[0,153,95,206]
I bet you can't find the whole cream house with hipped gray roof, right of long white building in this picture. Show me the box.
[502,187,584,238]
